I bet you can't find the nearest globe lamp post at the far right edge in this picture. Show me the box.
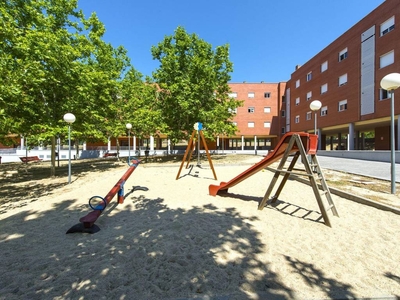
[381,73,400,194]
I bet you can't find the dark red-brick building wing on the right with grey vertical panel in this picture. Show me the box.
[285,0,400,150]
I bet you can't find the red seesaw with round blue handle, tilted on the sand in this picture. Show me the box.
[67,160,140,233]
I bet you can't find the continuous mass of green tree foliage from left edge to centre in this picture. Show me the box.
[0,0,240,171]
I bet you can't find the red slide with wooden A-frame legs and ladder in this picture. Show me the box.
[209,132,339,227]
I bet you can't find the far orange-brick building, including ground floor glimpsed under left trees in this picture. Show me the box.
[87,82,286,153]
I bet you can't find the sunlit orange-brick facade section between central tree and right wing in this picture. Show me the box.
[224,82,286,150]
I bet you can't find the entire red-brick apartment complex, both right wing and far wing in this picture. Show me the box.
[4,0,400,156]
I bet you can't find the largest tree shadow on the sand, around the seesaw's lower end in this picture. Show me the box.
[0,195,294,299]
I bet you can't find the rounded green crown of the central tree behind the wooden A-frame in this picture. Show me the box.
[151,27,242,142]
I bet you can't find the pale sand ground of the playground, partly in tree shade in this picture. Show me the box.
[0,157,400,300]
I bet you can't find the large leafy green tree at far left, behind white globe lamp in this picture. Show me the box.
[0,0,136,174]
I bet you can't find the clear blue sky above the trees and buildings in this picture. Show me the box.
[78,0,384,83]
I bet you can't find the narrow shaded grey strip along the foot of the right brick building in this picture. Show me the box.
[317,150,400,163]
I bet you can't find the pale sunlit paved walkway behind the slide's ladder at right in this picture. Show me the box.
[318,156,400,183]
